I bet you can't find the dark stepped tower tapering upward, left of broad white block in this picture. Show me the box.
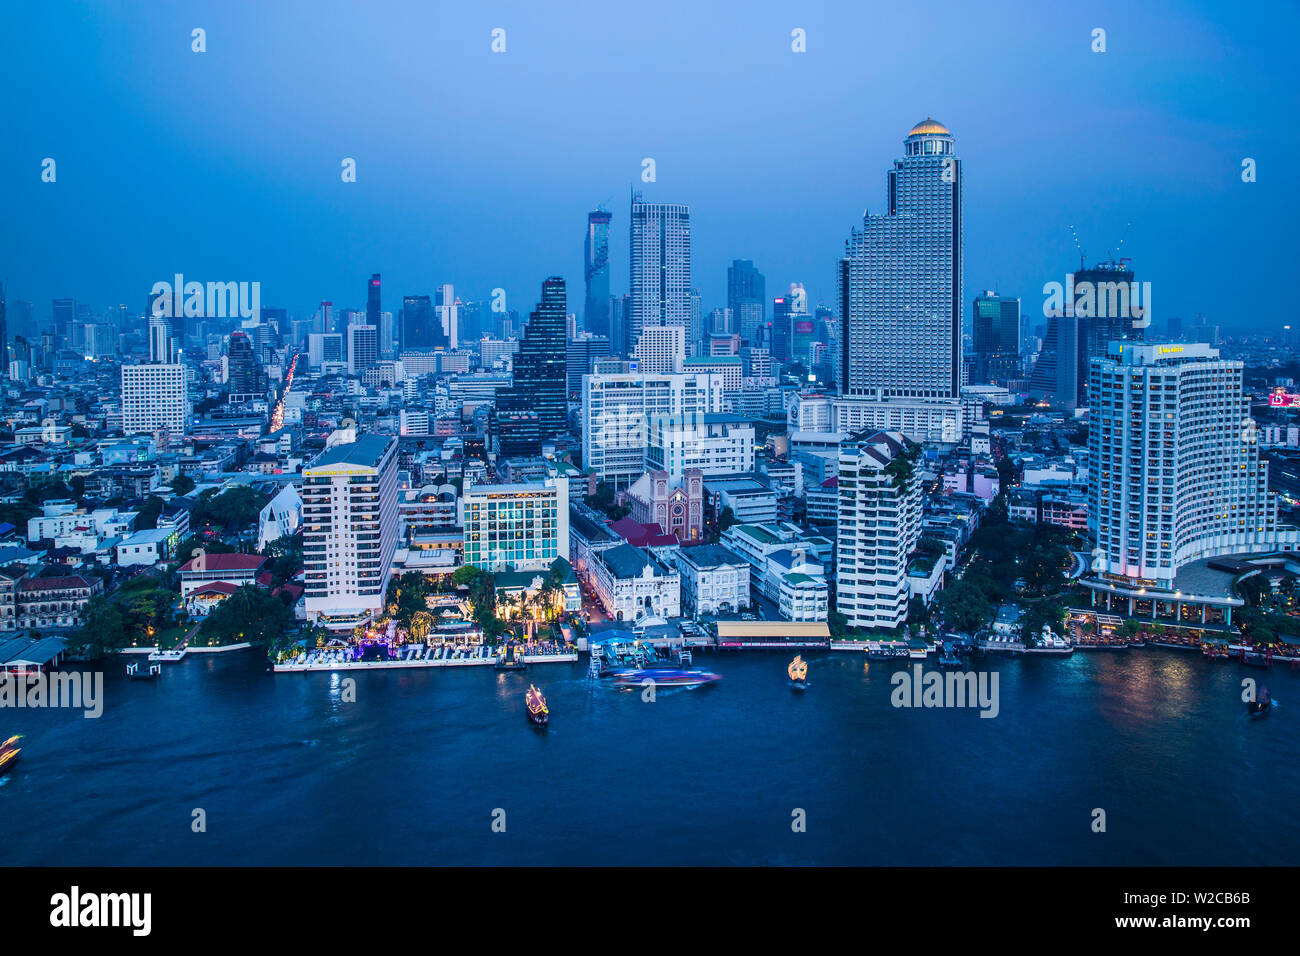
[497,276,568,457]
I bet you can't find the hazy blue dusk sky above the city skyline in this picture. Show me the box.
[0,0,1300,329]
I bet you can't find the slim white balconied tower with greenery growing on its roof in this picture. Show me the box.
[835,432,920,628]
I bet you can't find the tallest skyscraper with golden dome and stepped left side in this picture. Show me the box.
[836,118,965,401]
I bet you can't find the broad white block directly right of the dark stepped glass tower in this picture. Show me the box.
[582,372,725,488]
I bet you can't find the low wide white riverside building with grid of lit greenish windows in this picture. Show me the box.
[459,476,569,571]
